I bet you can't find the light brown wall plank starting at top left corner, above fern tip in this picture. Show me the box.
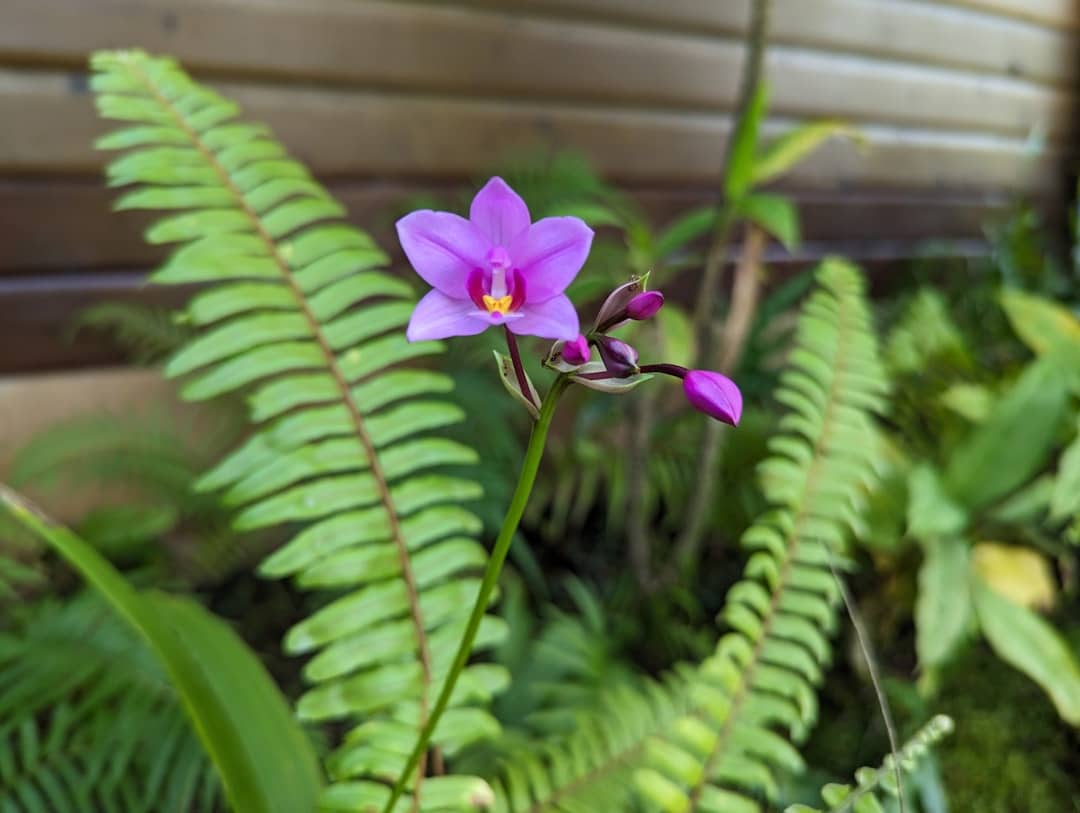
[0,0,1076,138]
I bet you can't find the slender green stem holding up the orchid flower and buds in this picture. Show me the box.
[382,376,570,813]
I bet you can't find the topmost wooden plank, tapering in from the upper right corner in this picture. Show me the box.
[455,0,1080,83]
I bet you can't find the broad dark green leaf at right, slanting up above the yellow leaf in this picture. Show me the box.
[944,358,1068,509]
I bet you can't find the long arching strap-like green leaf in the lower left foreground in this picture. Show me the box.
[0,486,321,813]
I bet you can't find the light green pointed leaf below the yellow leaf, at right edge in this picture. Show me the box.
[972,580,1080,726]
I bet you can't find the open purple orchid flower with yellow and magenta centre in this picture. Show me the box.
[397,177,593,341]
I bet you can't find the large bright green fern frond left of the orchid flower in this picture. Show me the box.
[93,52,507,810]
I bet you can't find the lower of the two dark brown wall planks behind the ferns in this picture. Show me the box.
[0,240,987,375]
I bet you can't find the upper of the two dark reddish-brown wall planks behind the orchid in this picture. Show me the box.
[0,178,1005,275]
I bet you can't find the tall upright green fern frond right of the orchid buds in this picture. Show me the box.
[637,260,887,813]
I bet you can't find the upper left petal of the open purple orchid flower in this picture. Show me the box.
[397,209,492,299]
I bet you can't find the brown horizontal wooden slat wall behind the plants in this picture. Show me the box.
[0,0,1080,370]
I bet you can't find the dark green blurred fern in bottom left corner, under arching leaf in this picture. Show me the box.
[0,594,221,813]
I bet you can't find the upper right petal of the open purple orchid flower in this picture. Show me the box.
[508,217,593,302]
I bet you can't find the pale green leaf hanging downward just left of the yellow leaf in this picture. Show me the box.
[915,539,972,668]
